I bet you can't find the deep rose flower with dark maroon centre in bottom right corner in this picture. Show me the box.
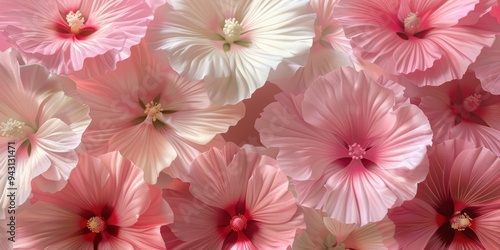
[388,140,500,249]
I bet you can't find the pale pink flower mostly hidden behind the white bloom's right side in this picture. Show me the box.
[270,0,353,93]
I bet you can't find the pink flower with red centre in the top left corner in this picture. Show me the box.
[0,0,153,77]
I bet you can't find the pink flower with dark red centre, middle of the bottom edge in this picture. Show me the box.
[163,143,302,249]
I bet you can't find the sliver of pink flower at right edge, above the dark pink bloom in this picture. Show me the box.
[470,36,500,95]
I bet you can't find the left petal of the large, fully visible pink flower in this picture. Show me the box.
[255,93,345,180]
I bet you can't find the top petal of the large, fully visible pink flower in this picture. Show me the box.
[302,68,396,145]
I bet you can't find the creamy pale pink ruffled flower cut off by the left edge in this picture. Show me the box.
[0,50,90,212]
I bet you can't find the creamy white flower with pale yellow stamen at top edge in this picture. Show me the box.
[147,0,315,105]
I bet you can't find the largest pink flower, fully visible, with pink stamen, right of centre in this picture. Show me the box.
[255,68,432,226]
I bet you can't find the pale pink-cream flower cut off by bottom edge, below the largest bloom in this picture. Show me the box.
[293,208,394,250]
